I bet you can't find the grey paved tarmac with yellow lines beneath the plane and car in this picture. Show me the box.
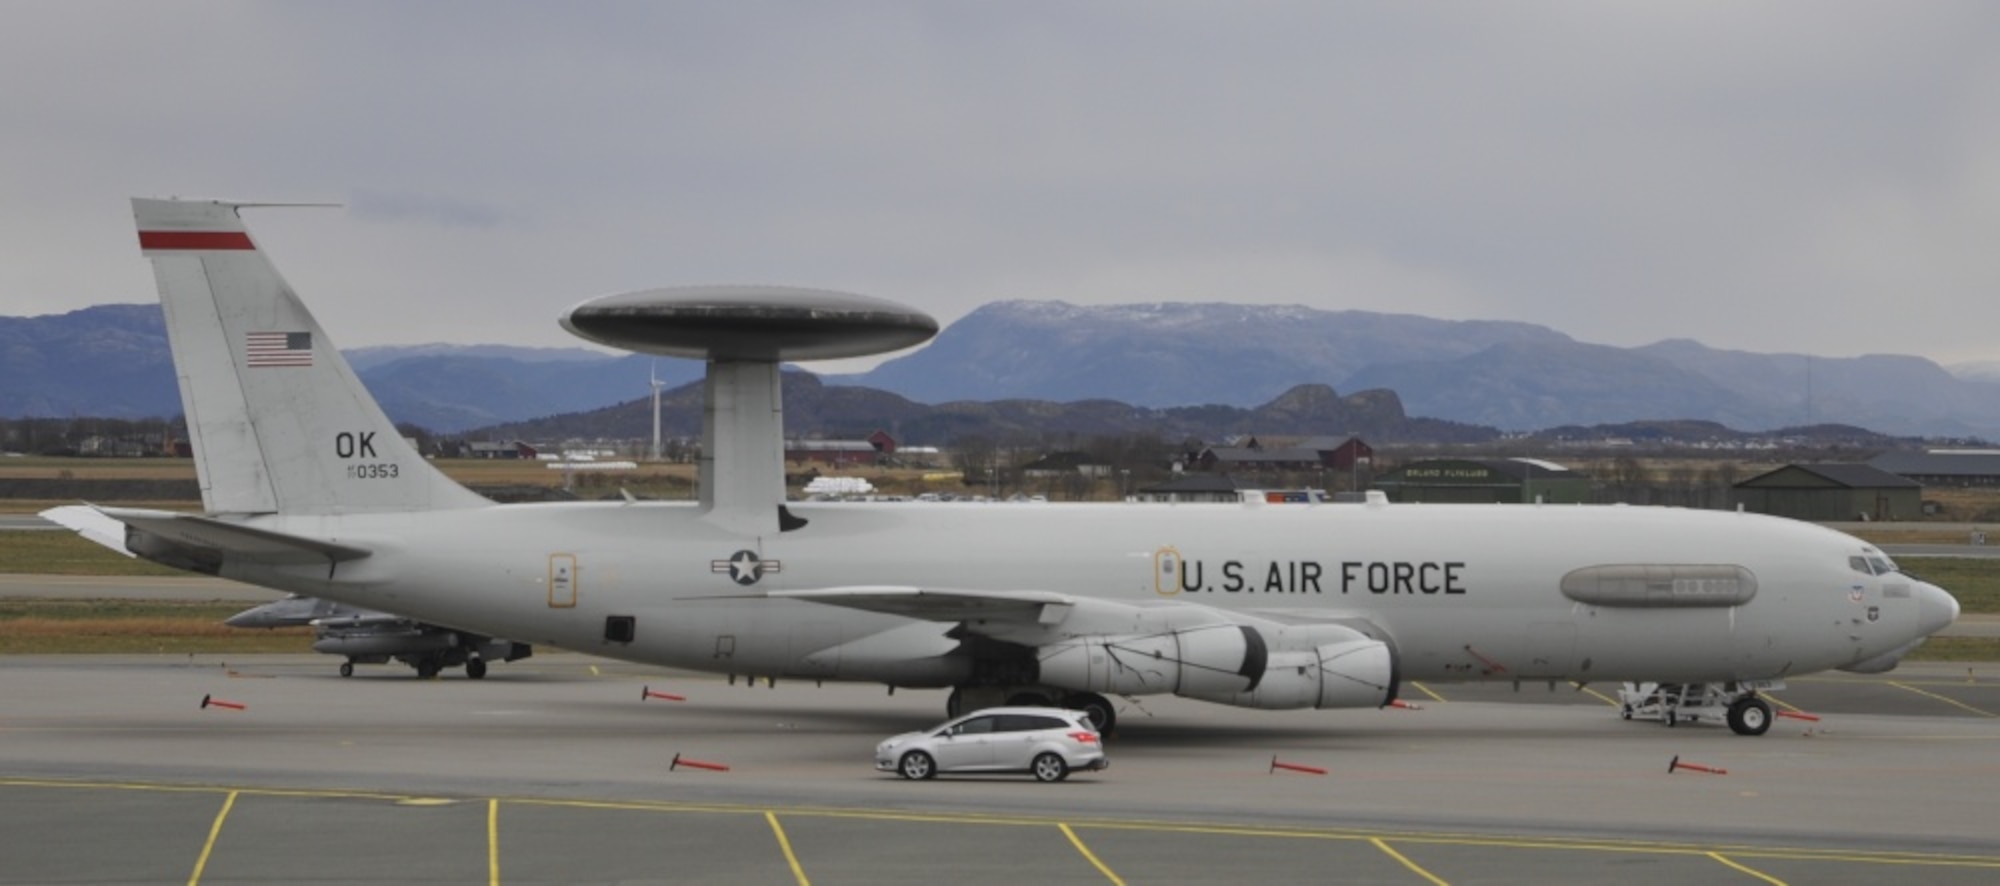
[0,654,2000,884]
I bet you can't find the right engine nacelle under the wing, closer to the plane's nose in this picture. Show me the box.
[1182,624,1398,710]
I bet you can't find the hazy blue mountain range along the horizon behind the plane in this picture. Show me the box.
[0,300,2000,444]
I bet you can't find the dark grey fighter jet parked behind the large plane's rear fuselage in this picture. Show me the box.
[222,594,534,680]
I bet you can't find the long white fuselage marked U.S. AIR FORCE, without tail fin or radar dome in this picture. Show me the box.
[223,502,1948,686]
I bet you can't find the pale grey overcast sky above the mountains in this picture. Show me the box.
[0,0,2000,372]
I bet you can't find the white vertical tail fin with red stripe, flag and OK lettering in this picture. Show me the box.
[132,198,490,514]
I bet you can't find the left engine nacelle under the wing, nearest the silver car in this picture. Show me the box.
[1038,624,1268,696]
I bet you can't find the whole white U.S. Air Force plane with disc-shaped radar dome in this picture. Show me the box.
[43,200,1958,734]
